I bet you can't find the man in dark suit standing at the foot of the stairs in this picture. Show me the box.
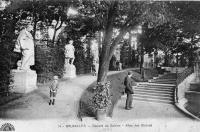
[124,71,134,110]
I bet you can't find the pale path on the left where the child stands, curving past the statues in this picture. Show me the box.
[0,74,96,119]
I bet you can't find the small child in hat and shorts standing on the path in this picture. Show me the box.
[49,76,58,105]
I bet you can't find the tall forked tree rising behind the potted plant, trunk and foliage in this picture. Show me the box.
[78,0,171,83]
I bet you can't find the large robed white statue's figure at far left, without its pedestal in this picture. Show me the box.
[14,25,35,70]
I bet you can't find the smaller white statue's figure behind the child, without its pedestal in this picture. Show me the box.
[65,40,75,65]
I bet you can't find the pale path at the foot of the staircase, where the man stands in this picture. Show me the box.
[113,95,194,121]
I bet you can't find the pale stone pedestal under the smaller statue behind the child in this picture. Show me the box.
[63,64,76,79]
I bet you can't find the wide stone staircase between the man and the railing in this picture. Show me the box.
[133,73,176,104]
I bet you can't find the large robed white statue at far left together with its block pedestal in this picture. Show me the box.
[11,25,37,93]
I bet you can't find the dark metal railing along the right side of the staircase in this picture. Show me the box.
[175,67,194,103]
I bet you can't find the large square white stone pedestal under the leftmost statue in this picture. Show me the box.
[11,70,37,93]
